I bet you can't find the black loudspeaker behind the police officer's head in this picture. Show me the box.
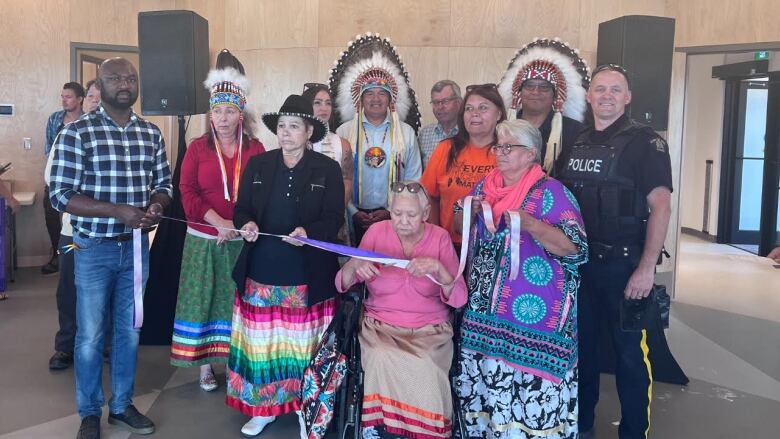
[596,15,674,131]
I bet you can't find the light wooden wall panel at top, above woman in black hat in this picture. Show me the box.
[225,0,319,50]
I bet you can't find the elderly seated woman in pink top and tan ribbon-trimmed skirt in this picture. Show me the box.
[336,182,466,438]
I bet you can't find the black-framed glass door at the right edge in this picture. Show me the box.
[713,61,780,255]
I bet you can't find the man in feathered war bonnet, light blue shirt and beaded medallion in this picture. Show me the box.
[330,34,422,244]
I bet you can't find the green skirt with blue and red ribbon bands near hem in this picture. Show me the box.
[171,233,243,367]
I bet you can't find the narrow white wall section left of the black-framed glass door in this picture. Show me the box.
[680,54,726,236]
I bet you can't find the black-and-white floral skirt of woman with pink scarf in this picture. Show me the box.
[455,350,577,439]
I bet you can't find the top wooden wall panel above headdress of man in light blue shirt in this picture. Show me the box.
[318,0,451,47]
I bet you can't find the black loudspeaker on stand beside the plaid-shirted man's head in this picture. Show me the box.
[138,11,209,116]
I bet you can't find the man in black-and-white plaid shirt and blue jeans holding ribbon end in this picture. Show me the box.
[49,58,172,439]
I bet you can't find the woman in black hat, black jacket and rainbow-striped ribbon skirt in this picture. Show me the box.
[227,95,344,437]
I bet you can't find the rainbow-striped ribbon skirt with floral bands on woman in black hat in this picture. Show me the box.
[226,279,335,416]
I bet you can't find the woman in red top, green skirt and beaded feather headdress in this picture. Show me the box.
[171,51,264,392]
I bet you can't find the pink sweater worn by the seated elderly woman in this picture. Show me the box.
[336,220,466,328]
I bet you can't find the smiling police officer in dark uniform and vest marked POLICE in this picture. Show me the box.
[558,65,672,439]
